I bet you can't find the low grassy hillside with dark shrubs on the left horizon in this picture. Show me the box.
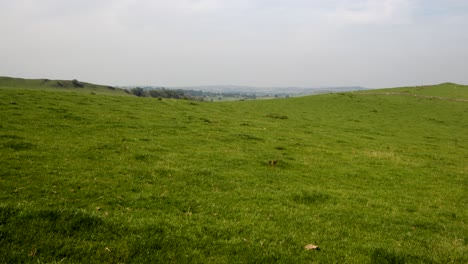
[0,76,127,95]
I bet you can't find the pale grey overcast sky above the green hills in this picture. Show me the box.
[0,0,468,88]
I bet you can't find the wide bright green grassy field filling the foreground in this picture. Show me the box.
[0,82,468,263]
